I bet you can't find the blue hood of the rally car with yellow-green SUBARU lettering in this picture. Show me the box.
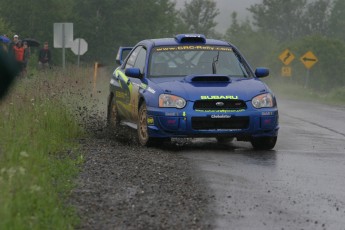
[150,77,268,101]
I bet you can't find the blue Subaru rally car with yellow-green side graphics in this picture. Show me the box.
[107,34,279,149]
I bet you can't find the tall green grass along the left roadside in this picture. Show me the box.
[0,67,89,229]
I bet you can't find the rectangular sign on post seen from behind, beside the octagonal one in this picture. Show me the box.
[54,23,73,69]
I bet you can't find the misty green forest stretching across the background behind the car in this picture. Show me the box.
[0,0,345,92]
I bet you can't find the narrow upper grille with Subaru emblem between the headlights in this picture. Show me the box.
[193,100,247,110]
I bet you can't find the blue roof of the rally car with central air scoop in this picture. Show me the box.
[139,34,230,48]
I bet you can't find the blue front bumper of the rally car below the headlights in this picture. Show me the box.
[147,105,279,140]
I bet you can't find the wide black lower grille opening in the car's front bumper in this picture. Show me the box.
[192,117,249,130]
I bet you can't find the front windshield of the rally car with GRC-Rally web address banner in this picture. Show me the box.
[149,45,250,77]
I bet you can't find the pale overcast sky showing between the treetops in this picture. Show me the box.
[176,0,262,33]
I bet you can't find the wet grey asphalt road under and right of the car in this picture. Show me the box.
[180,100,345,230]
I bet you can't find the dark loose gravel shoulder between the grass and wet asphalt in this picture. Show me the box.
[71,116,212,229]
